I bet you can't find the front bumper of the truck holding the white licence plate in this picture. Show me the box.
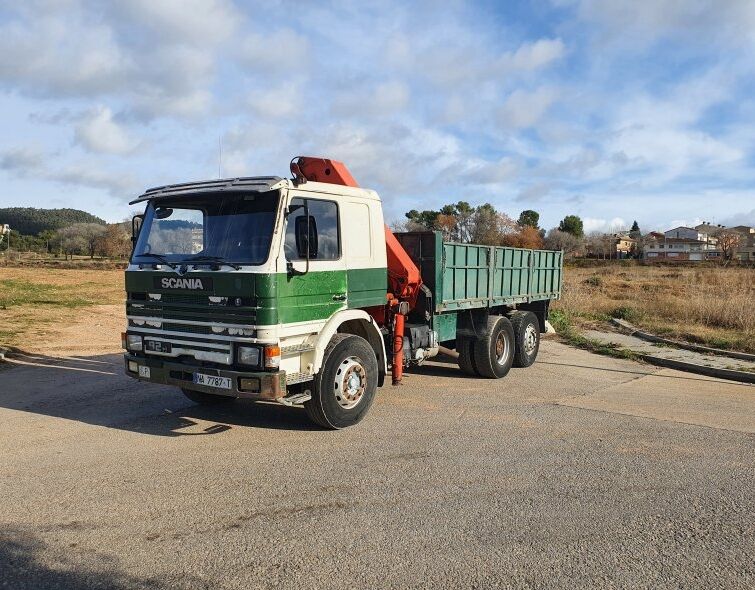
[123,353,286,400]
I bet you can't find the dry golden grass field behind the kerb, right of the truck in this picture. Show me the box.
[554,262,755,352]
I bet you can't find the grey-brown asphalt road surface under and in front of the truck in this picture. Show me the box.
[0,342,755,590]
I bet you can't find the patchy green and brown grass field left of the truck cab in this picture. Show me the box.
[0,267,124,349]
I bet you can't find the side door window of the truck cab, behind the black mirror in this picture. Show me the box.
[285,197,341,260]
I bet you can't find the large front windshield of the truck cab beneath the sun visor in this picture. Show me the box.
[133,191,279,265]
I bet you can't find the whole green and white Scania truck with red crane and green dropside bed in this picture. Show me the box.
[122,157,563,428]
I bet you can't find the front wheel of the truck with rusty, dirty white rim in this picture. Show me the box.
[304,334,378,429]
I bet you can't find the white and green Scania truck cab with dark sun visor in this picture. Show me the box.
[124,177,387,428]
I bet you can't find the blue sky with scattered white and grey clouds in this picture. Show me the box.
[0,0,755,231]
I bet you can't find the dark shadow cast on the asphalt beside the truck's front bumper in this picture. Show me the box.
[0,354,321,436]
